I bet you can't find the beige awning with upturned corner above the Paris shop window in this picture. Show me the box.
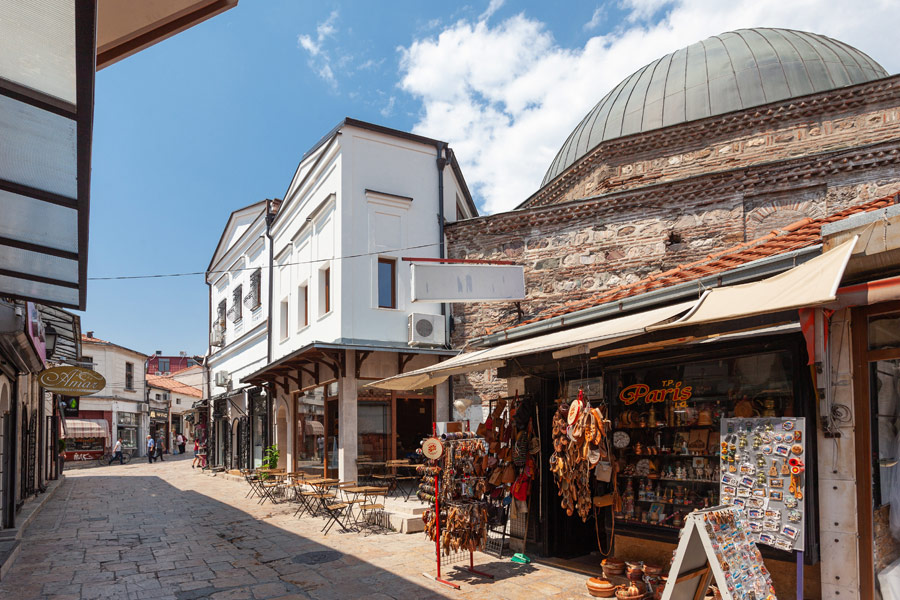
[649,237,857,330]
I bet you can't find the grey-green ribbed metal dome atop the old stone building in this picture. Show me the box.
[541,28,888,186]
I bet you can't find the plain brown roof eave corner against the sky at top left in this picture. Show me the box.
[97,0,238,70]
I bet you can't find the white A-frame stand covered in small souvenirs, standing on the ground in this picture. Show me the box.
[662,506,776,600]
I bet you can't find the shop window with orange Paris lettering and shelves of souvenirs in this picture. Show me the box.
[606,351,794,529]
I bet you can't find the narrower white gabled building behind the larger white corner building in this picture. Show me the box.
[207,200,278,468]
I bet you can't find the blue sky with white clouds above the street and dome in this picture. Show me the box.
[82,0,900,355]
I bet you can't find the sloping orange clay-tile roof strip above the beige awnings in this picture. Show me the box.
[496,193,900,334]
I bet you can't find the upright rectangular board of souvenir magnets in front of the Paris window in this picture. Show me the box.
[719,418,806,552]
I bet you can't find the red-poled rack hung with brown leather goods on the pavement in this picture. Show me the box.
[418,429,494,589]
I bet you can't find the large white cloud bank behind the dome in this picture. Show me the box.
[400,0,900,213]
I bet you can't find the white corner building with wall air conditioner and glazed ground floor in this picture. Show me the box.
[242,119,477,480]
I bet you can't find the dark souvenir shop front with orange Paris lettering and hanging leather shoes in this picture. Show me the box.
[526,333,819,597]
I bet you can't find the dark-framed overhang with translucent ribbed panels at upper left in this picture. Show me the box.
[0,0,97,310]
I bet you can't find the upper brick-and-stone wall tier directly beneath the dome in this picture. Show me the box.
[523,76,900,207]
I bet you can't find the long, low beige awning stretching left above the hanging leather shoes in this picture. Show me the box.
[369,302,695,390]
